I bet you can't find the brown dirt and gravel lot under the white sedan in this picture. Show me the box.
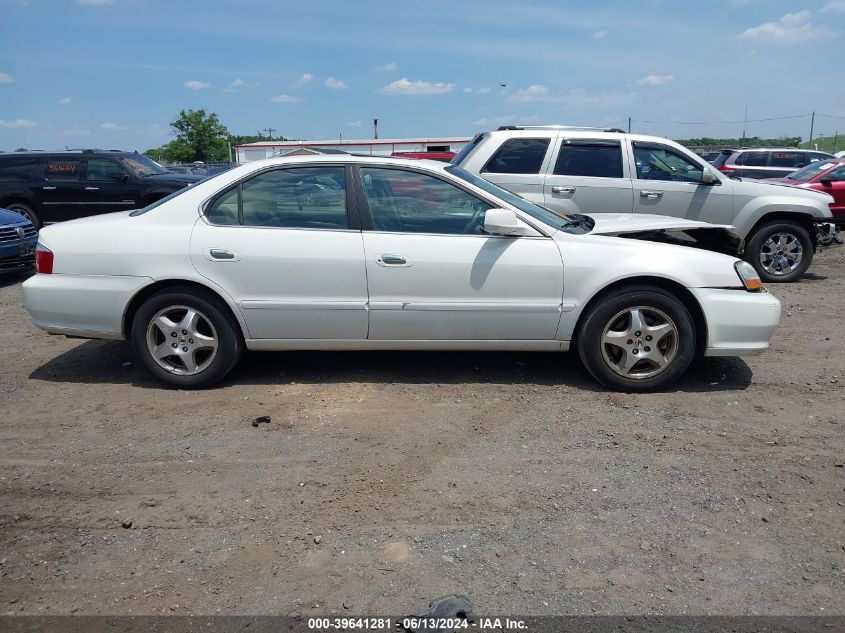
[0,249,845,615]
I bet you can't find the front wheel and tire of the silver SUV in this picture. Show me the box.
[745,220,813,283]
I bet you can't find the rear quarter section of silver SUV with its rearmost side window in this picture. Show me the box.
[480,132,557,204]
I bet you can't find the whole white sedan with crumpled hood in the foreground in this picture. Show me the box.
[18,155,780,391]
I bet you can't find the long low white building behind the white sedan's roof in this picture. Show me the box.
[234,137,471,163]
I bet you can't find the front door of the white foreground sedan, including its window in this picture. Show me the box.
[352,165,563,341]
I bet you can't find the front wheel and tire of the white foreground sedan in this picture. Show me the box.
[576,286,696,392]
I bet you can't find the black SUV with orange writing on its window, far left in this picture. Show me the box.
[0,149,204,227]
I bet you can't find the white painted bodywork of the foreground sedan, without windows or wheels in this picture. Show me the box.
[24,155,780,366]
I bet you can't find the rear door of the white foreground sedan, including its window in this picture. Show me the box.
[190,163,367,340]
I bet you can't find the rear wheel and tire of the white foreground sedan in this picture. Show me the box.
[131,288,244,389]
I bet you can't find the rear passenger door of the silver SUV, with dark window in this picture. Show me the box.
[543,137,634,213]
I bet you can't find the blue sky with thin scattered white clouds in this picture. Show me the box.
[0,0,845,151]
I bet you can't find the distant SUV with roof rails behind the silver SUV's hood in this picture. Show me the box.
[713,147,833,178]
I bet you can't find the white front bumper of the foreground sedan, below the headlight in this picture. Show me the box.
[690,288,780,356]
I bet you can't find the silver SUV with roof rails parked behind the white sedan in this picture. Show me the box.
[452,125,837,282]
